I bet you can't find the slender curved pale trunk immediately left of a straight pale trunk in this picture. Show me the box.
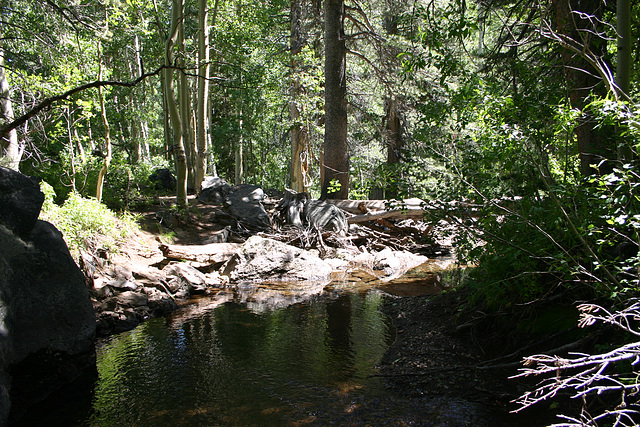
[164,0,187,209]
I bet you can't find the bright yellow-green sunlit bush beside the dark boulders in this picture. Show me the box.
[40,181,138,258]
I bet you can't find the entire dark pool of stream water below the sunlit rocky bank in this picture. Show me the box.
[13,258,540,426]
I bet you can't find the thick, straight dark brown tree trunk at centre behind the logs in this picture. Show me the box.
[321,0,349,199]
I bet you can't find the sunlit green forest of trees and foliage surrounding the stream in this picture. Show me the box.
[0,0,640,425]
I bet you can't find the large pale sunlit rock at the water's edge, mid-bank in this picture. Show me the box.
[223,236,332,282]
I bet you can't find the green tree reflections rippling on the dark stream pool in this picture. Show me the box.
[86,292,390,425]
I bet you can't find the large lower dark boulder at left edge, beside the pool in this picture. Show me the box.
[0,221,95,363]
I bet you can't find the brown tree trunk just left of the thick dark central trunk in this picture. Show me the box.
[289,0,309,193]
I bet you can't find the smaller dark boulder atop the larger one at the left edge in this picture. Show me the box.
[0,166,44,236]
